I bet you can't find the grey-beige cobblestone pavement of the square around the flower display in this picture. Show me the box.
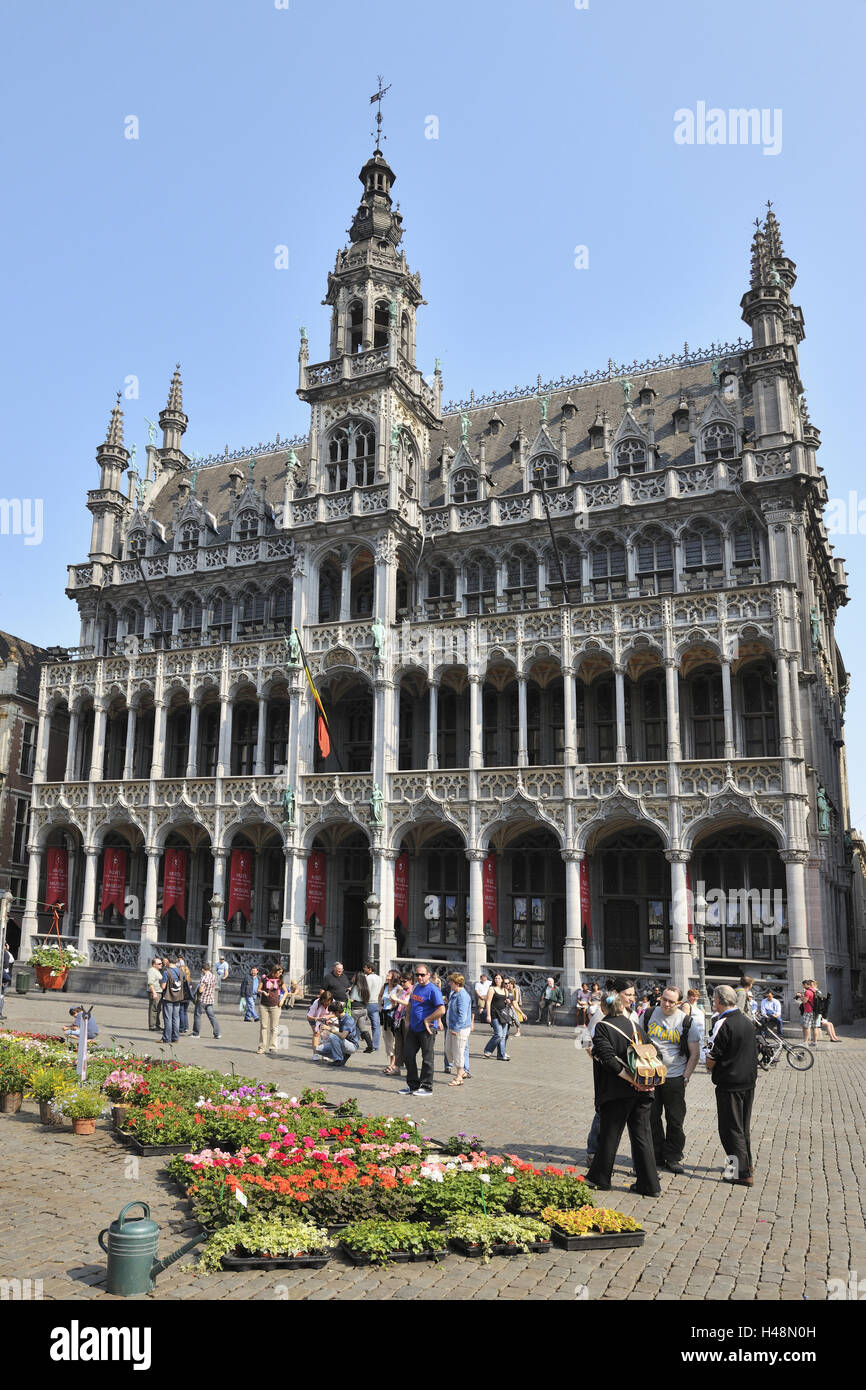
[0,994,866,1301]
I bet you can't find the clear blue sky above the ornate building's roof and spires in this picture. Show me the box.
[0,0,866,826]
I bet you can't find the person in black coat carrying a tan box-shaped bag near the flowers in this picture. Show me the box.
[587,994,662,1197]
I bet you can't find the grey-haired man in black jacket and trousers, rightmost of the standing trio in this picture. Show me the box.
[706,984,758,1187]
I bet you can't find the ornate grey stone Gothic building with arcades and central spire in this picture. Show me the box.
[25,149,852,999]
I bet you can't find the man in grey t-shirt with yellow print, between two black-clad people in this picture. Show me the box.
[641,984,701,1173]
